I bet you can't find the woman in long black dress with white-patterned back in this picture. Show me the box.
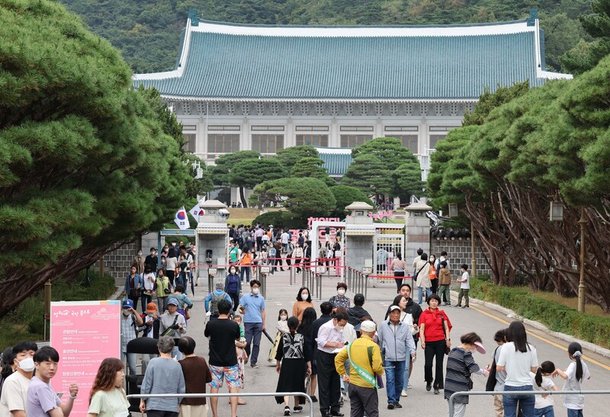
[275,316,311,416]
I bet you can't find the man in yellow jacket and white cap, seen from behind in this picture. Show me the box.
[335,320,383,417]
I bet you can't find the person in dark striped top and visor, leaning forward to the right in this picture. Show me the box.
[444,333,488,417]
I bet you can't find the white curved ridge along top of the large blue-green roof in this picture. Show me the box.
[191,20,535,37]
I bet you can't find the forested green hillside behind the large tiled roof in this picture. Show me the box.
[60,0,591,73]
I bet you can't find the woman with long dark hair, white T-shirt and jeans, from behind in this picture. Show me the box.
[496,321,538,417]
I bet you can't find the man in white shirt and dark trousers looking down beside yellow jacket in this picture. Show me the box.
[316,311,348,417]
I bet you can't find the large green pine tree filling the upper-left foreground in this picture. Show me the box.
[0,0,192,315]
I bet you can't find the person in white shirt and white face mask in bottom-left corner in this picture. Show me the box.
[0,342,38,417]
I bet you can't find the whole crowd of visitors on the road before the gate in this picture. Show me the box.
[0,234,590,417]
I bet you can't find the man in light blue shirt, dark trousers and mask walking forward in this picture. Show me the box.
[239,279,267,368]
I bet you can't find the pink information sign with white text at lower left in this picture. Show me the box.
[51,300,121,416]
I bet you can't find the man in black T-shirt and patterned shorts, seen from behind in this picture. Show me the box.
[204,300,245,417]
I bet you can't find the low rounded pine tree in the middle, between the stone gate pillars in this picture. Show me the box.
[250,178,337,219]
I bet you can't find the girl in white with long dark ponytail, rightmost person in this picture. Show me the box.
[555,342,591,417]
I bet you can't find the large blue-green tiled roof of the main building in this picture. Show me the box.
[134,22,564,100]
